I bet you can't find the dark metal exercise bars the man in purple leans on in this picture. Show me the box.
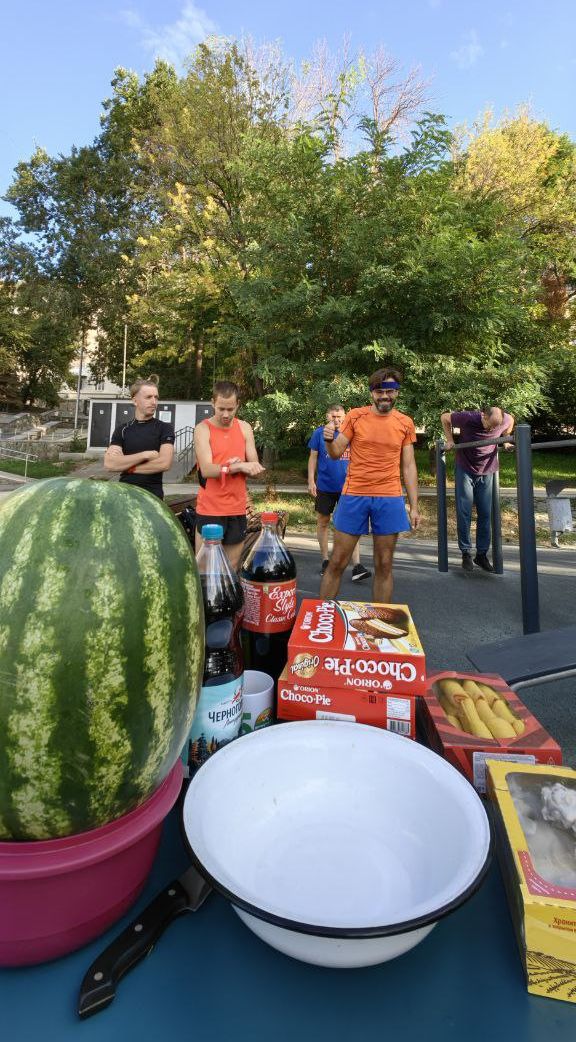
[435,423,576,634]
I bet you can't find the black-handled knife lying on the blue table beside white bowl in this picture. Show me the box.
[78,865,212,1018]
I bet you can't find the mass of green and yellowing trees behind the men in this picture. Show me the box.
[0,41,576,427]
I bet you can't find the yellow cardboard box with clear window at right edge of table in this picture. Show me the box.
[486,760,576,1002]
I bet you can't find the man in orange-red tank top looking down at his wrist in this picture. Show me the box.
[194,380,264,569]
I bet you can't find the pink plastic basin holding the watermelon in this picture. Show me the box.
[0,760,182,966]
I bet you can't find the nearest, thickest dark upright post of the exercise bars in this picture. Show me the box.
[516,423,540,634]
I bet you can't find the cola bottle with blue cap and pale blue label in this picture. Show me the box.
[189,524,244,768]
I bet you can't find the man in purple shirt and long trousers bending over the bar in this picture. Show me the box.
[441,405,514,572]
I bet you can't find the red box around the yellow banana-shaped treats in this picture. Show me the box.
[418,670,562,793]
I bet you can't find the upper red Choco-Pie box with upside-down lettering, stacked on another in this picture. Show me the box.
[286,600,426,695]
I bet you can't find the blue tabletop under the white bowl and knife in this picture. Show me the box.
[0,812,576,1042]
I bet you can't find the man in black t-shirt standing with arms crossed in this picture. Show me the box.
[104,379,174,499]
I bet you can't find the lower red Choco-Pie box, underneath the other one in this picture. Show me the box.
[276,668,416,738]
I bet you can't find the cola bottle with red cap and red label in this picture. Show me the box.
[240,514,296,680]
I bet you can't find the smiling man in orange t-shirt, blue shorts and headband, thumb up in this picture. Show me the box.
[320,368,420,603]
